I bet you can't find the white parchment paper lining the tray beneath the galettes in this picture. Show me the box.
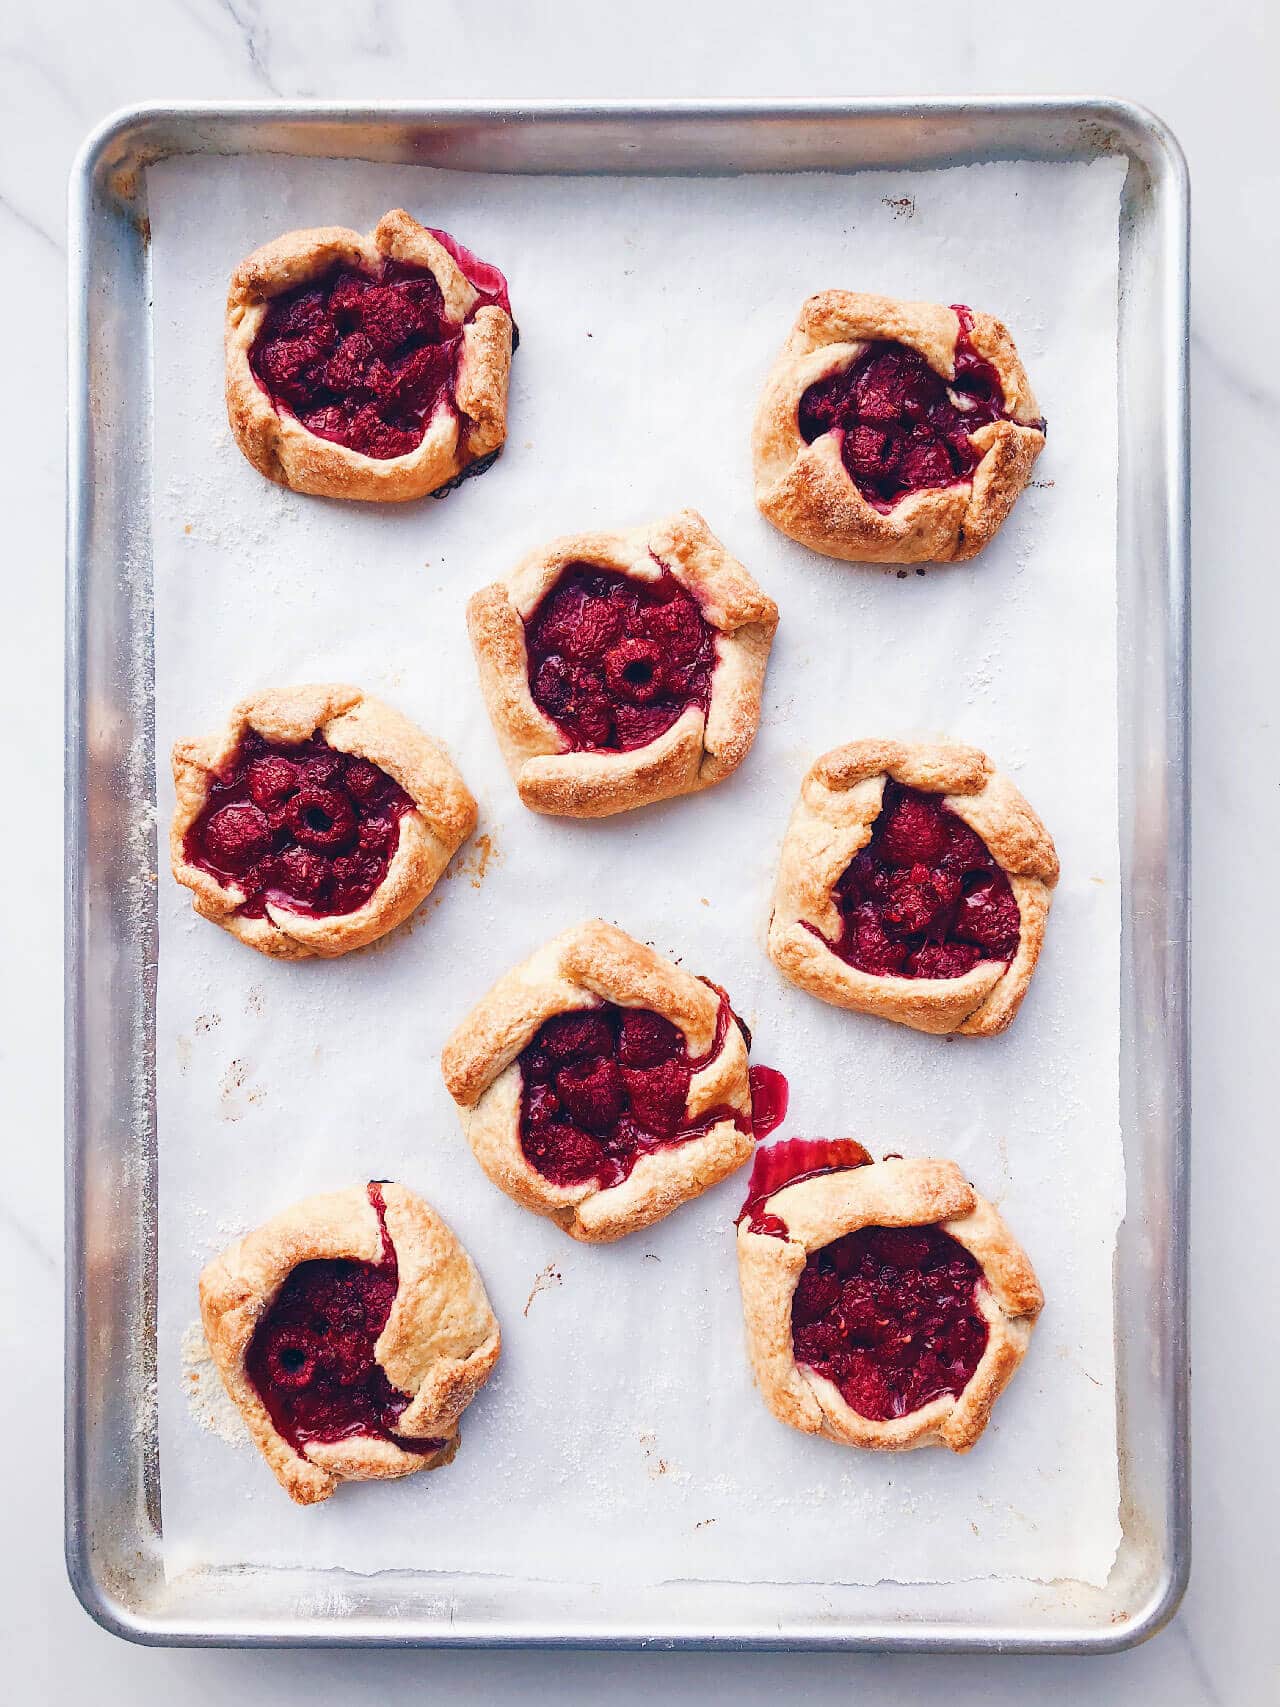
[148,159,1123,1582]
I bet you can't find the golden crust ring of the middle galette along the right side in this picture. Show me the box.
[768,741,1058,1036]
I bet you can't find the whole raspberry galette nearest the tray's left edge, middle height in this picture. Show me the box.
[169,685,476,959]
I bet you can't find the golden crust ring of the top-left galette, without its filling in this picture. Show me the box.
[225,208,512,504]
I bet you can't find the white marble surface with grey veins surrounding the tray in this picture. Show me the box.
[0,0,1280,1707]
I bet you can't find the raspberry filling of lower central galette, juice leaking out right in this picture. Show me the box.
[519,992,771,1190]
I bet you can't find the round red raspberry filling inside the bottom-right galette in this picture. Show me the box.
[792,1226,986,1422]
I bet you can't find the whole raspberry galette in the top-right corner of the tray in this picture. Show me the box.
[753,290,1044,563]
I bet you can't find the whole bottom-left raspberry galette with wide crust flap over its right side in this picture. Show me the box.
[200,1180,502,1506]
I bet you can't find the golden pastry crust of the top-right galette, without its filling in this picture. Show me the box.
[751,290,1044,563]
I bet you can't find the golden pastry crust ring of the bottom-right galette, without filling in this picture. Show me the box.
[737,1159,1044,1453]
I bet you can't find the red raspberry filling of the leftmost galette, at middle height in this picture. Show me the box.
[184,729,413,918]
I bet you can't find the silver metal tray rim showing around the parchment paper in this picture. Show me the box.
[65,97,1190,1652]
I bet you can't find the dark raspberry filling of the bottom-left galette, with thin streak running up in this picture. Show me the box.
[246,1181,444,1453]
